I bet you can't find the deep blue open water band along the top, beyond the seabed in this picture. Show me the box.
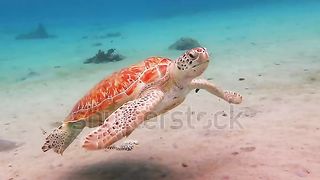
[0,0,317,23]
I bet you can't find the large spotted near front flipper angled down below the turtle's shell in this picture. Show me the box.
[83,89,164,150]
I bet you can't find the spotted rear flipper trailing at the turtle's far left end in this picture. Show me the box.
[42,121,85,154]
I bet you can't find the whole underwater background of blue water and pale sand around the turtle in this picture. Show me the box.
[0,0,320,180]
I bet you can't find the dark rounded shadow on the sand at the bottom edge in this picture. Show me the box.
[64,160,175,180]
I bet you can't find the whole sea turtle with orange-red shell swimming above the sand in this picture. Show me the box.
[42,47,242,154]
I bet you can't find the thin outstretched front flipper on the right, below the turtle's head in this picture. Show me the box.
[190,79,242,104]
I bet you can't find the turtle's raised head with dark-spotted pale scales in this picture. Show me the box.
[174,47,209,84]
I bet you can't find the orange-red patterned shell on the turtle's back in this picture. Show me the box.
[65,57,171,122]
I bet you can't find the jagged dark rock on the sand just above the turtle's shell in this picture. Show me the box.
[83,49,125,64]
